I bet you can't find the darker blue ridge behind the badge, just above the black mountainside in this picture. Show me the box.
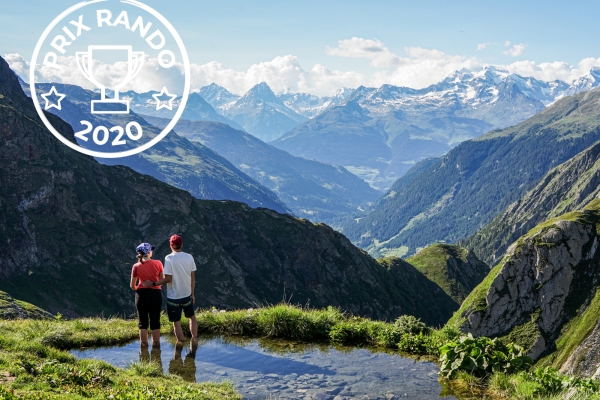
[27,84,289,212]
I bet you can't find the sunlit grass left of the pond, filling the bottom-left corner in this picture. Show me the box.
[0,318,241,400]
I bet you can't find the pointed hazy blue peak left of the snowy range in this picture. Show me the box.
[222,82,307,142]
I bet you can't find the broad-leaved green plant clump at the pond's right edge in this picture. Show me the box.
[440,334,533,379]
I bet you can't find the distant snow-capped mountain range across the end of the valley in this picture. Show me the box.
[193,66,600,189]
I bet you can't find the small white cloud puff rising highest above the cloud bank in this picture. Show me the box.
[326,37,401,68]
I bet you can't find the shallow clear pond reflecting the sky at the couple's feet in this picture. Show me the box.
[71,336,454,400]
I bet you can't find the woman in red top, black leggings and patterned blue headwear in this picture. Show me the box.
[129,243,164,346]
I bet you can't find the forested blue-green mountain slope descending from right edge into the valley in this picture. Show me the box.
[343,89,600,255]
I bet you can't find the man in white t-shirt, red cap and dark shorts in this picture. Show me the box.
[143,235,198,345]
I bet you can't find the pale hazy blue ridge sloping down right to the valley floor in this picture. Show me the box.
[141,117,381,225]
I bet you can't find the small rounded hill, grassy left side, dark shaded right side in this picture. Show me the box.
[406,243,490,306]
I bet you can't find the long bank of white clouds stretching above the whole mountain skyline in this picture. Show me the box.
[4,38,600,96]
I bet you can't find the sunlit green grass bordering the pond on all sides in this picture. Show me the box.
[0,302,600,400]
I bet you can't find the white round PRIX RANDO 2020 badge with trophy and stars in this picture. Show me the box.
[29,0,191,158]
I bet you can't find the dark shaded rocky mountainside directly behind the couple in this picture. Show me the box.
[0,59,453,324]
